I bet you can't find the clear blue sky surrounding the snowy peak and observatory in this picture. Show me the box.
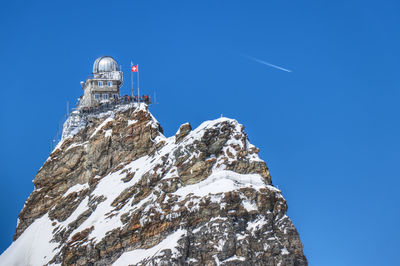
[0,0,400,266]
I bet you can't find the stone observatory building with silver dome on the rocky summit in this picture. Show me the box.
[79,56,123,108]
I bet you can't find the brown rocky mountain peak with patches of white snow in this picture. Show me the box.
[0,105,307,265]
